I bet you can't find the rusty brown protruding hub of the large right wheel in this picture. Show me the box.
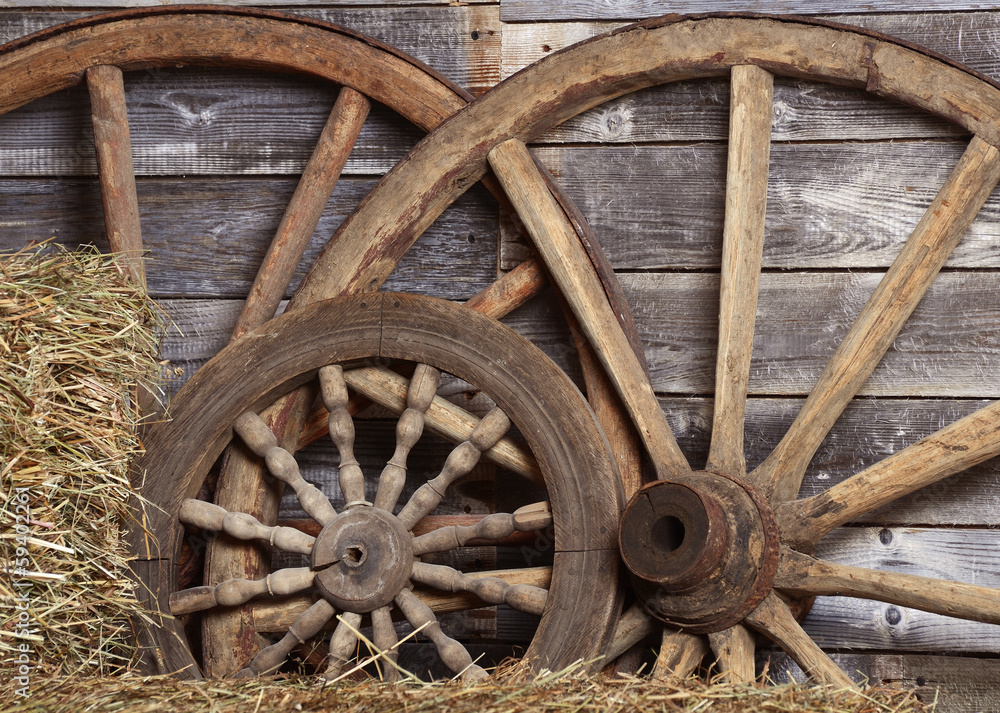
[619,471,779,633]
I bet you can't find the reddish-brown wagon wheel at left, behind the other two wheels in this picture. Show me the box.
[0,5,624,676]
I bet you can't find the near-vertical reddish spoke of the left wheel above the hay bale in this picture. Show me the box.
[86,65,146,285]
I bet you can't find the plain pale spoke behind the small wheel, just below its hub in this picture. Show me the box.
[251,567,552,636]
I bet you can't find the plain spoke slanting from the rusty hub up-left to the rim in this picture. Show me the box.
[489,139,690,478]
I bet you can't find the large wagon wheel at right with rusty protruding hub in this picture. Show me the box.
[270,16,1000,685]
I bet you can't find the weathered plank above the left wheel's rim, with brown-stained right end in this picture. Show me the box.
[0,5,500,94]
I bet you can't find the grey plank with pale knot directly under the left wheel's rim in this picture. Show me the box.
[0,75,422,176]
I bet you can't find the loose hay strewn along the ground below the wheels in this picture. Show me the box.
[0,666,933,713]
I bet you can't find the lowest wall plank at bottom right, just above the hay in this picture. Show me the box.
[757,651,1000,713]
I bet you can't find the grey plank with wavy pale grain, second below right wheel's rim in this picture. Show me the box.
[501,141,1000,270]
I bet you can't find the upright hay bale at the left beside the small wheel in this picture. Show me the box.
[0,243,157,676]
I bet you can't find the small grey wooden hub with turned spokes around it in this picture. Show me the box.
[312,506,413,614]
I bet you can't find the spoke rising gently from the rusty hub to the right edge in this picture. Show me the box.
[775,401,1000,549]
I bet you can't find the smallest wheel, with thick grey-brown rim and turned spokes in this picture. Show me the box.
[136,293,620,678]
